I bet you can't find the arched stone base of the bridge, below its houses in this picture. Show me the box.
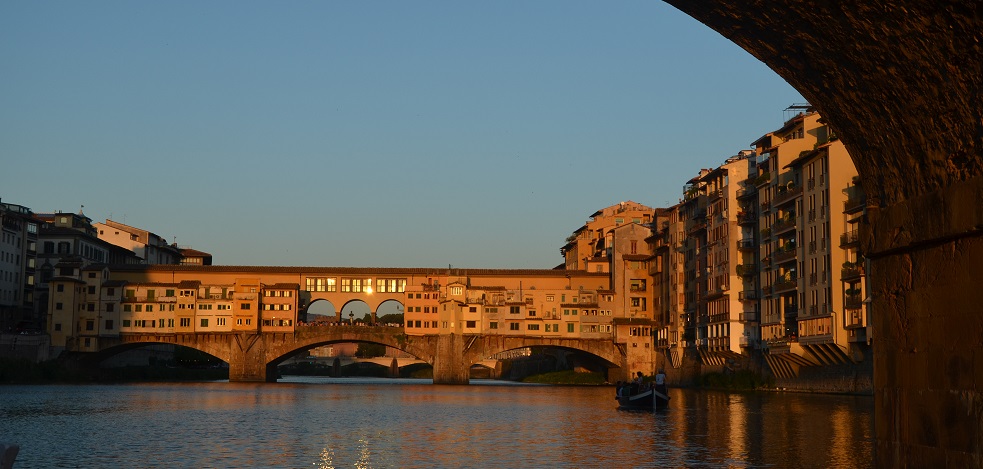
[86,326,628,384]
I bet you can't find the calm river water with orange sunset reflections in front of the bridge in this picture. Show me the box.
[0,377,873,468]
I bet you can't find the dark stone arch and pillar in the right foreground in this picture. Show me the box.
[665,0,983,467]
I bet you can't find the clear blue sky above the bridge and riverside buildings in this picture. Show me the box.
[0,0,803,268]
